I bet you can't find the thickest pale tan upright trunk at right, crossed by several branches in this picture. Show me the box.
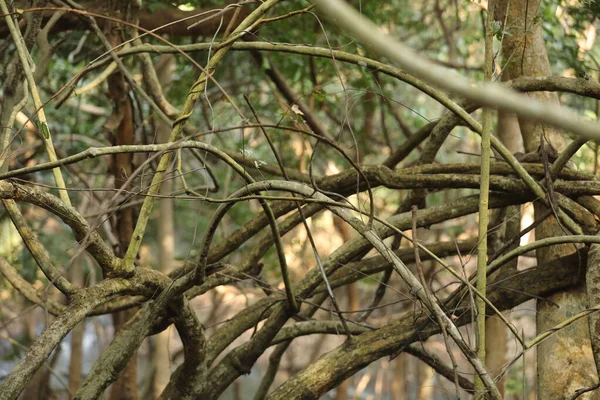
[497,0,597,400]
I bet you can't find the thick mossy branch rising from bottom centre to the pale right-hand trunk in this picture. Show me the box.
[267,254,586,400]
